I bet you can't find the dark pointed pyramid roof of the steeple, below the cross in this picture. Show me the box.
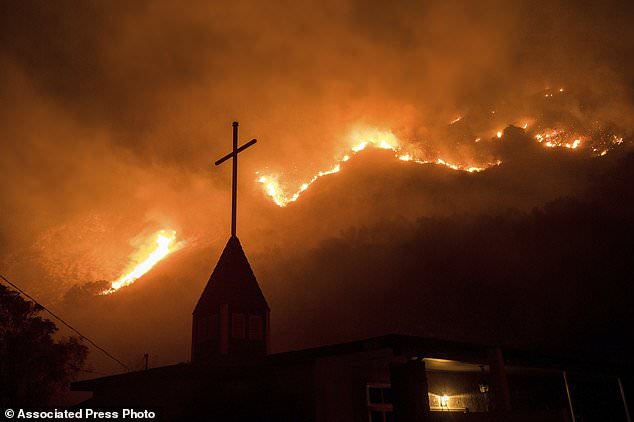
[194,236,269,314]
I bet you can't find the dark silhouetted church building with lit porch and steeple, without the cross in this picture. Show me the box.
[72,236,629,422]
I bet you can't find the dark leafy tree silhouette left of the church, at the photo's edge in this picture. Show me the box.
[0,285,88,408]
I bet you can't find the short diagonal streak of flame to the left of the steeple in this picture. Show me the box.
[101,230,180,295]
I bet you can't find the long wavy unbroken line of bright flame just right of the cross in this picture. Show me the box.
[257,129,500,207]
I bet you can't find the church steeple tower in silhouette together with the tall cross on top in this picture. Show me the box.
[192,122,270,362]
